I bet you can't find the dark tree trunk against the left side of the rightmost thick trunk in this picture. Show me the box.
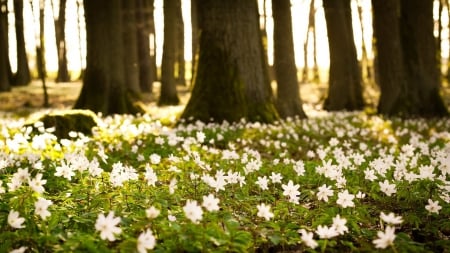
[372,0,409,115]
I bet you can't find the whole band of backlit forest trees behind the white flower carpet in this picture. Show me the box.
[0,0,450,118]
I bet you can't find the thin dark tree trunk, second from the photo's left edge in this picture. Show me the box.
[13,0,31,86]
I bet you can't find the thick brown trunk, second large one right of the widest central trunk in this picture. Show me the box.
[323,0,364,111]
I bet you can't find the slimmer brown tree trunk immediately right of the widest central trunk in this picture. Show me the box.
[272,0,306,118]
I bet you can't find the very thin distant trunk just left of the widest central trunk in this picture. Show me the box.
[175,1,186,86]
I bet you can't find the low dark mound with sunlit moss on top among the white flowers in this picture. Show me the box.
[27,110,98,139]
